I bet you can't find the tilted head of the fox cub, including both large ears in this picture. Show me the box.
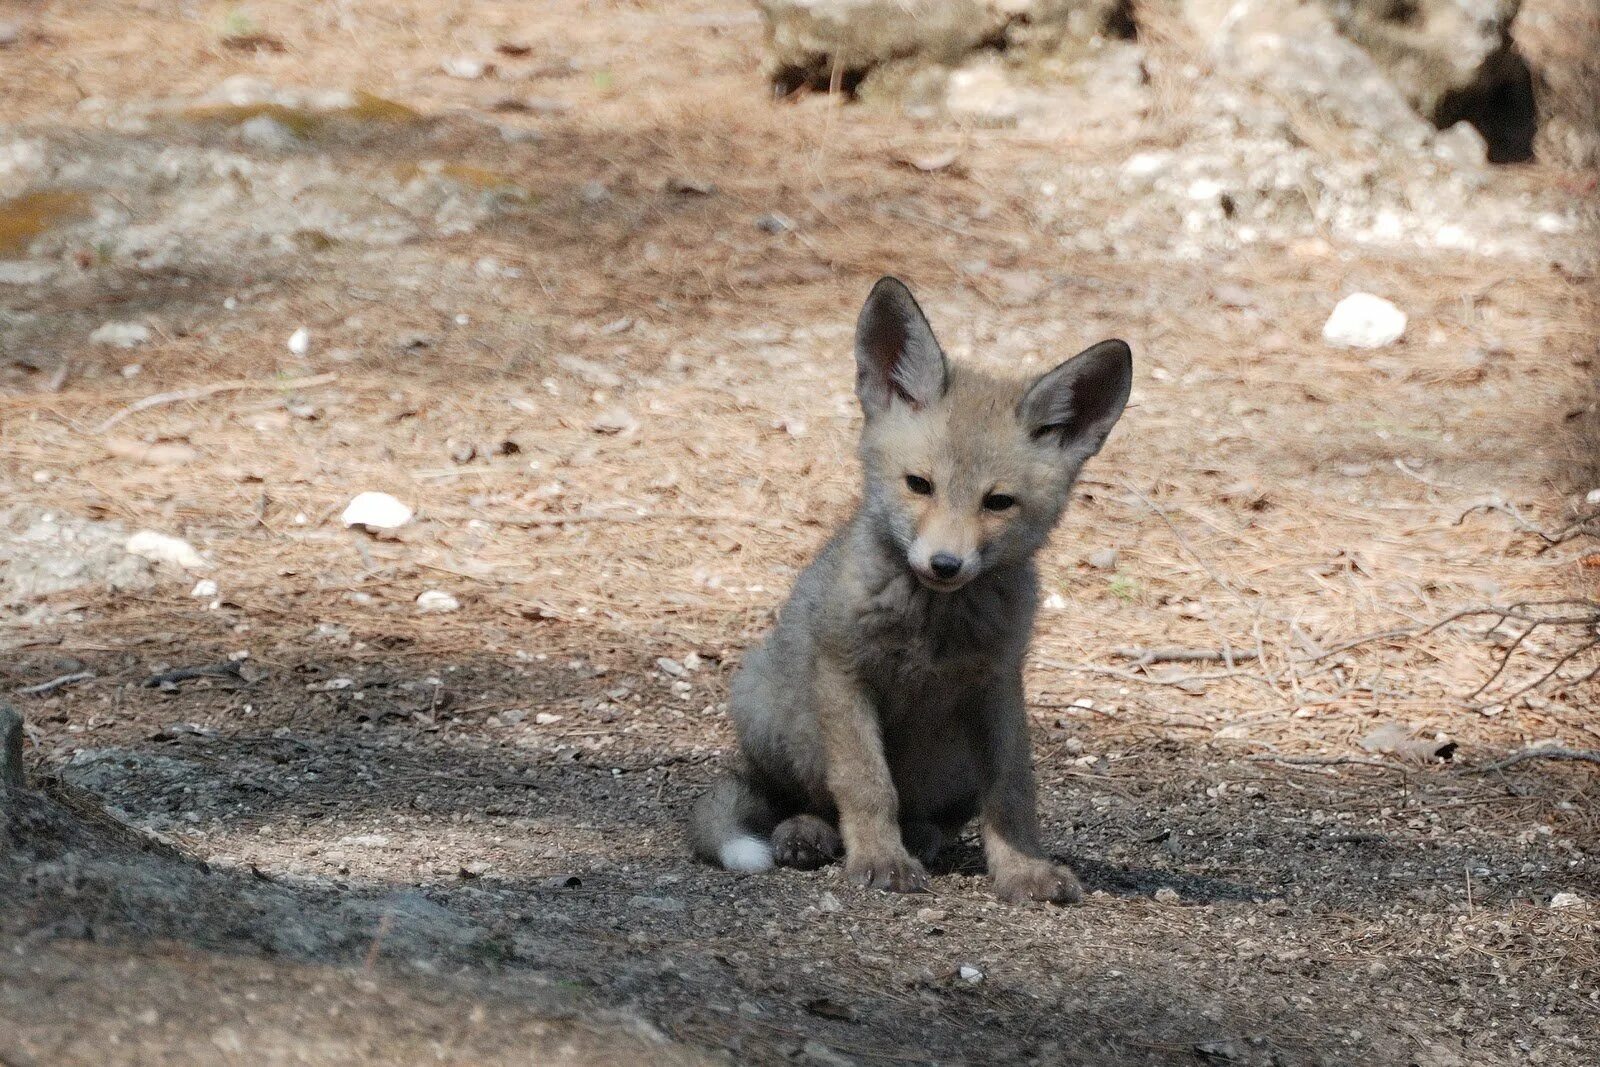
[856,278,1133,592]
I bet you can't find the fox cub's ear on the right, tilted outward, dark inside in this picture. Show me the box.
[1018,341,1133,462]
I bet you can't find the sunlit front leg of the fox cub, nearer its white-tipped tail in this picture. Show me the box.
[816,657,928,893]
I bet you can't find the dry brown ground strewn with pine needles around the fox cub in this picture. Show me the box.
[0,0,1600,1065]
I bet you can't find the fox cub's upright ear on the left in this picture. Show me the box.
[856,278,947,416]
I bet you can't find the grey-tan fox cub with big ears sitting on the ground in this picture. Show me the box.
[691,278,1133,901]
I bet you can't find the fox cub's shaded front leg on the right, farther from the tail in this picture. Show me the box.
[982,672,1083,904]
